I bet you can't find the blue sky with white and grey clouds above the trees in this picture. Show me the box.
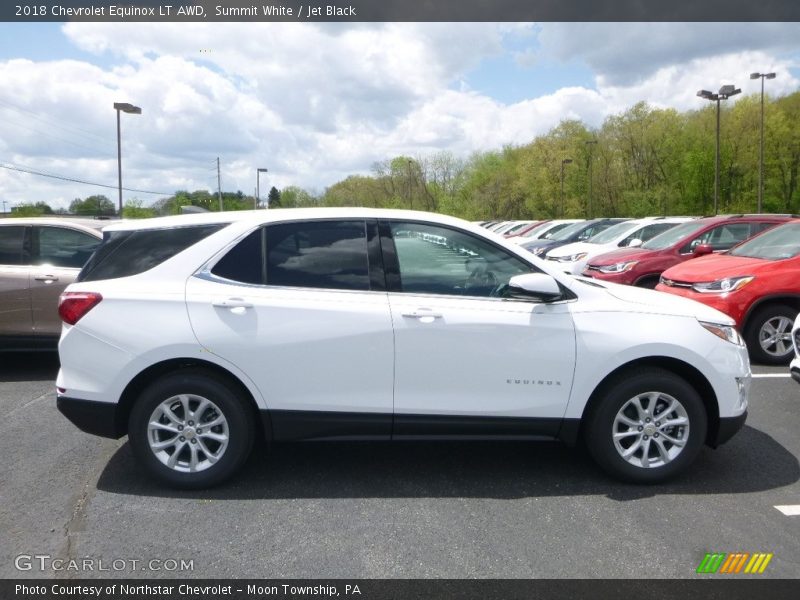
[0,22,800,210]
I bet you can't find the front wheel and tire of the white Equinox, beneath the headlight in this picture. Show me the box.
[584,368,708,483]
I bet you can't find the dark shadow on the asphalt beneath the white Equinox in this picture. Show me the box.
[97,426,800,501]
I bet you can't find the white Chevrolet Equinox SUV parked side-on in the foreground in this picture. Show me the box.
[57,208,750,487]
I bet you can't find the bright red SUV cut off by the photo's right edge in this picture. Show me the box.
[656,219,800,365]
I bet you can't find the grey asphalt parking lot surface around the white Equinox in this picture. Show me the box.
[0,355,800,578]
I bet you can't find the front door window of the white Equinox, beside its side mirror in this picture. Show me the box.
[390,222,535,296]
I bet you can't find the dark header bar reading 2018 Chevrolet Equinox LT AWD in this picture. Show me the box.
[0,0,800,23]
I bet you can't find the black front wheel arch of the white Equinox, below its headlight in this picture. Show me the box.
[559,356,719,445]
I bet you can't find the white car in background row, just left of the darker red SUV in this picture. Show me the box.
[545,217,691,275]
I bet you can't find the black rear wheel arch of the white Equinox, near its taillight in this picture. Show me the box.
[115,358,272,440]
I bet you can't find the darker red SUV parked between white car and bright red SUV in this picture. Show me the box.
[583,215,791,288]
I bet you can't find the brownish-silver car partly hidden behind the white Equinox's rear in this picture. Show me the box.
[0,218,103,350]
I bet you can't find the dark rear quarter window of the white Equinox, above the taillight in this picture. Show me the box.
[77,224,225,281]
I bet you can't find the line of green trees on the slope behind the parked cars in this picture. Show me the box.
[7,92,800,220]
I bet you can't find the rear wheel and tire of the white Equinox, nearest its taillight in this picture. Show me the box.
[128,369,254,489]
